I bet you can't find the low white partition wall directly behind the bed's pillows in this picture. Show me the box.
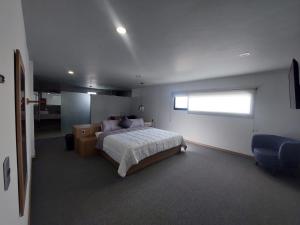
[91,95,131,123]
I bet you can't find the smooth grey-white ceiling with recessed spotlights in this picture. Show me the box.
[23,0,300,89]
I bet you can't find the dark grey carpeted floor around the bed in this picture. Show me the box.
[31,138,300,225]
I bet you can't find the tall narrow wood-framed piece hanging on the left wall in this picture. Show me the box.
[14,50,28,216]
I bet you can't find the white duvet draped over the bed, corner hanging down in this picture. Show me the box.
[102,128,186,177]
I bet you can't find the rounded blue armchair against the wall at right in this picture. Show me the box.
[252,134,300,170]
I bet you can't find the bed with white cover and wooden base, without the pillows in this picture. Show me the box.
[96,127,187,177]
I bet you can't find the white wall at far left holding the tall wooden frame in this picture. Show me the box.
[0,0,34,225]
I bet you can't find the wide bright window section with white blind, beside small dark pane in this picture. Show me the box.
[188,90,254,115]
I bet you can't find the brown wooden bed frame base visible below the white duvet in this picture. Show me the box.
[98,145,181,176]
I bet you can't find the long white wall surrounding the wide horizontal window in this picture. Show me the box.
[132,70,300,155]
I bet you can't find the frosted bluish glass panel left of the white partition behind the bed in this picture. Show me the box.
[61,92,91,134]
